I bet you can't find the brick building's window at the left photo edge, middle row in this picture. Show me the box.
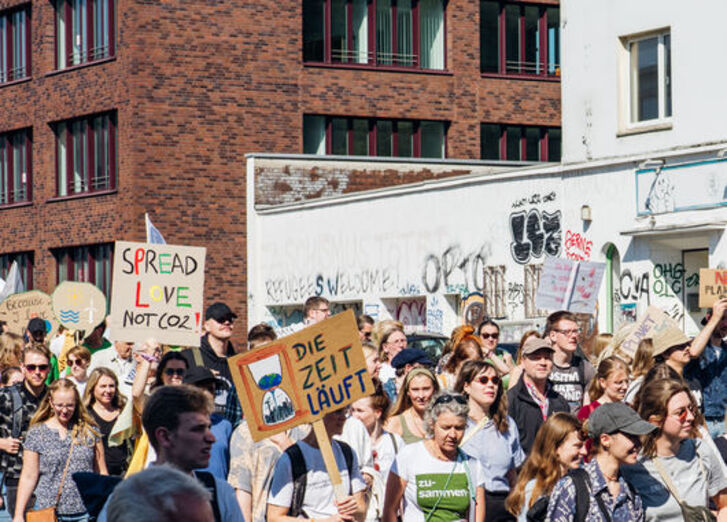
[0,129,32,205]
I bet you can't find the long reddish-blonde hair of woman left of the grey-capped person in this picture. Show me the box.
[505,412,584,516]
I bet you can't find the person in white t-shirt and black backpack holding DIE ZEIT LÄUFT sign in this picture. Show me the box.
[268,409,366,522]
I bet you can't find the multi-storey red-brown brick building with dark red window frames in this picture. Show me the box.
[0,0,560,342]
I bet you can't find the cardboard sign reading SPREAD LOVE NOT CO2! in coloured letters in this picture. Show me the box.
[109,241,206,346]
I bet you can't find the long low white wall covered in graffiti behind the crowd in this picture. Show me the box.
[248,152,727,341]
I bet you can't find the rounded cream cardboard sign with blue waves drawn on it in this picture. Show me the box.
[51,281,106,331]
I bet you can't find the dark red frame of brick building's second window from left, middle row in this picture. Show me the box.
[51,110,118,199]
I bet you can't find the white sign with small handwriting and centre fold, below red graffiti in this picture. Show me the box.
[535,257,606,314]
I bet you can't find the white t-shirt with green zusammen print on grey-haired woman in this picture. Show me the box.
[391,441,485,522]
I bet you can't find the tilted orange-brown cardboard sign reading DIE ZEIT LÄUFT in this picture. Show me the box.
[227,310,374,441]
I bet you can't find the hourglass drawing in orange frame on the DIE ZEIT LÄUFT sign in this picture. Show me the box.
[238,345,306,430]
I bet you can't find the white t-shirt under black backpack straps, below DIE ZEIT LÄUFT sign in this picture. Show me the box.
[268,440,366,518]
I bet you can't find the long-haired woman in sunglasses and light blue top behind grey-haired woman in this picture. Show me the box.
[455,360,525,522]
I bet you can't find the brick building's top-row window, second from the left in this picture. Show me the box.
[55,0,115,69]
